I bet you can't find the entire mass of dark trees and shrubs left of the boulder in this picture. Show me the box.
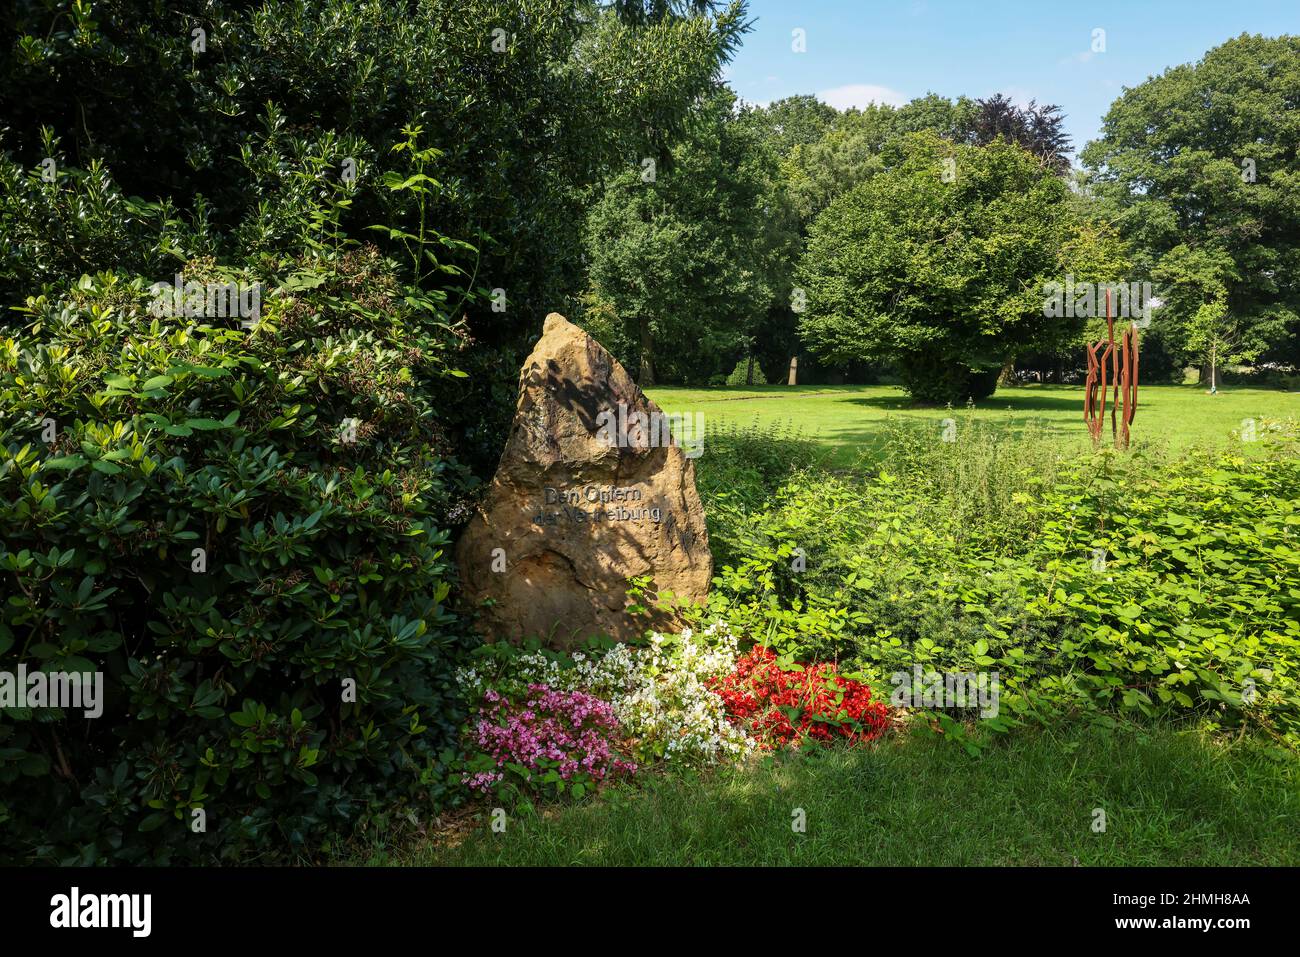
[0,0,746,862]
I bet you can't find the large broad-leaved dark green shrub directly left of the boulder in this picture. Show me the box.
[0,248,471,863]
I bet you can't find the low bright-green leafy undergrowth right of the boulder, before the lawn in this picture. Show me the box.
[707,423,1300,748]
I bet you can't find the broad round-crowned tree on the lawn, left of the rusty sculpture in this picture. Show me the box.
[798,133,1127,402]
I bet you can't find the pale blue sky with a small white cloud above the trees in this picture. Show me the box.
[725,0,1300,160]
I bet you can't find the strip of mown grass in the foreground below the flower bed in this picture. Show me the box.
[371,726,1300,866]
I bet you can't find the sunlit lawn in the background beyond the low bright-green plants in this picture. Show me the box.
[647,385,1300,464]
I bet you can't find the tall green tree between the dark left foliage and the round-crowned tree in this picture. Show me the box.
[586,90,794,386]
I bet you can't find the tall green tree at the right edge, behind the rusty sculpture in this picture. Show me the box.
[1083,34,1300,372]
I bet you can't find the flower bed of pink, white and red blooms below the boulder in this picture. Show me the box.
[458,622,887,796]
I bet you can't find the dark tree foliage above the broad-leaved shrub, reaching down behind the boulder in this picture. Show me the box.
[0,0,746,469]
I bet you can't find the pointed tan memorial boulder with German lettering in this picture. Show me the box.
[456,312,712,648]
